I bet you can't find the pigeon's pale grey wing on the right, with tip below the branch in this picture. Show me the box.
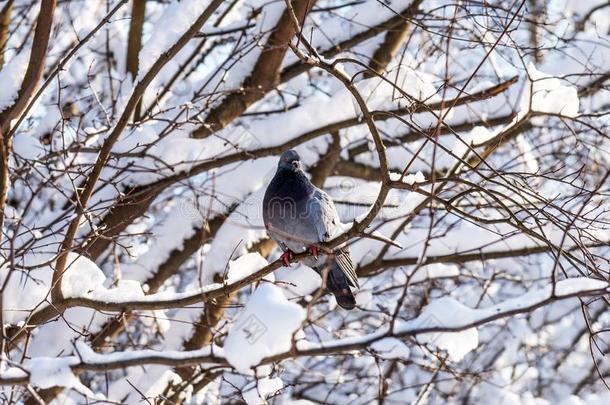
[309,189,358,287]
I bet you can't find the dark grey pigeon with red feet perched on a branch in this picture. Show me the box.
[263,150,359,310]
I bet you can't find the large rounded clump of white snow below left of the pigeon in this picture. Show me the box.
[224,282,305,373]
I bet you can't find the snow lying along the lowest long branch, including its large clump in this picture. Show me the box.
[0,278,610,388]
